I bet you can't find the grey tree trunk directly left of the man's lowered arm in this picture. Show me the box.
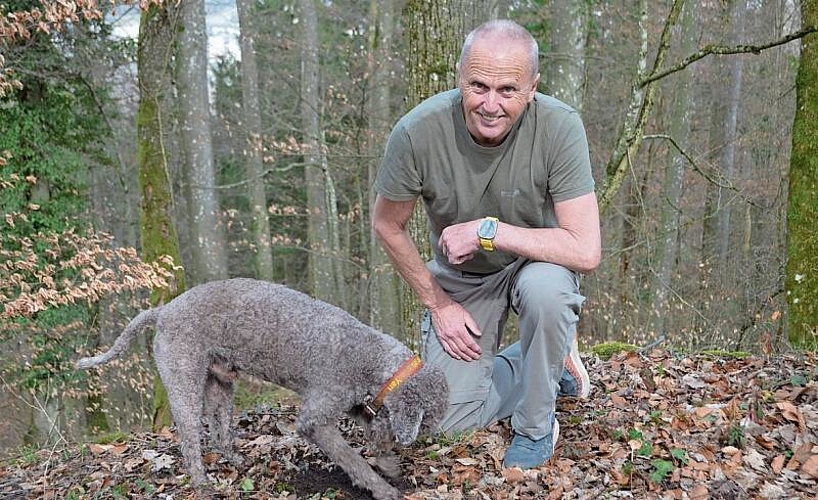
[365,0,400,340]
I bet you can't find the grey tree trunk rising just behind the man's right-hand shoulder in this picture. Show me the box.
[542,0,590,111]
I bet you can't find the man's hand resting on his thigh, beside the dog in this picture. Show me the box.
[429,302,482,361]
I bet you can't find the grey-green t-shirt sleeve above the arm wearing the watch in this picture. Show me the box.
[548,112,594,202]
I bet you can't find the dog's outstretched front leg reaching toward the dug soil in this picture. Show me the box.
[296,402,403,500]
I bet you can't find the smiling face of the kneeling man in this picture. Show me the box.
[458,39,540,146]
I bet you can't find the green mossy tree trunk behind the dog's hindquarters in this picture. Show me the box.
[136,4,185,430]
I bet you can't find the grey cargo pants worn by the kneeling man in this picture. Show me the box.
[421,258,585,440]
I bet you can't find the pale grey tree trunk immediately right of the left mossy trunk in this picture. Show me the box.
[176,0,227,283]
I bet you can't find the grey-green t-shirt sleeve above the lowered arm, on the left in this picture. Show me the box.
[375,122,421,201]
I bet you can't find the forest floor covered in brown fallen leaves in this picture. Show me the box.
[0,350,818,500]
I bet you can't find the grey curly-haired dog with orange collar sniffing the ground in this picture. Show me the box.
[76,278,448,500]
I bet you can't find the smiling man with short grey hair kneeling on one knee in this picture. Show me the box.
[372,17,601,468]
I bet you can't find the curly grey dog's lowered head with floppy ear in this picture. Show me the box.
[371,364,449,446]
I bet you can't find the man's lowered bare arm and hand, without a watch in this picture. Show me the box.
[372,195,480,361]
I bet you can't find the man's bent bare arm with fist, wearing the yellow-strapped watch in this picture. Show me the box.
[439,192,602,273]
